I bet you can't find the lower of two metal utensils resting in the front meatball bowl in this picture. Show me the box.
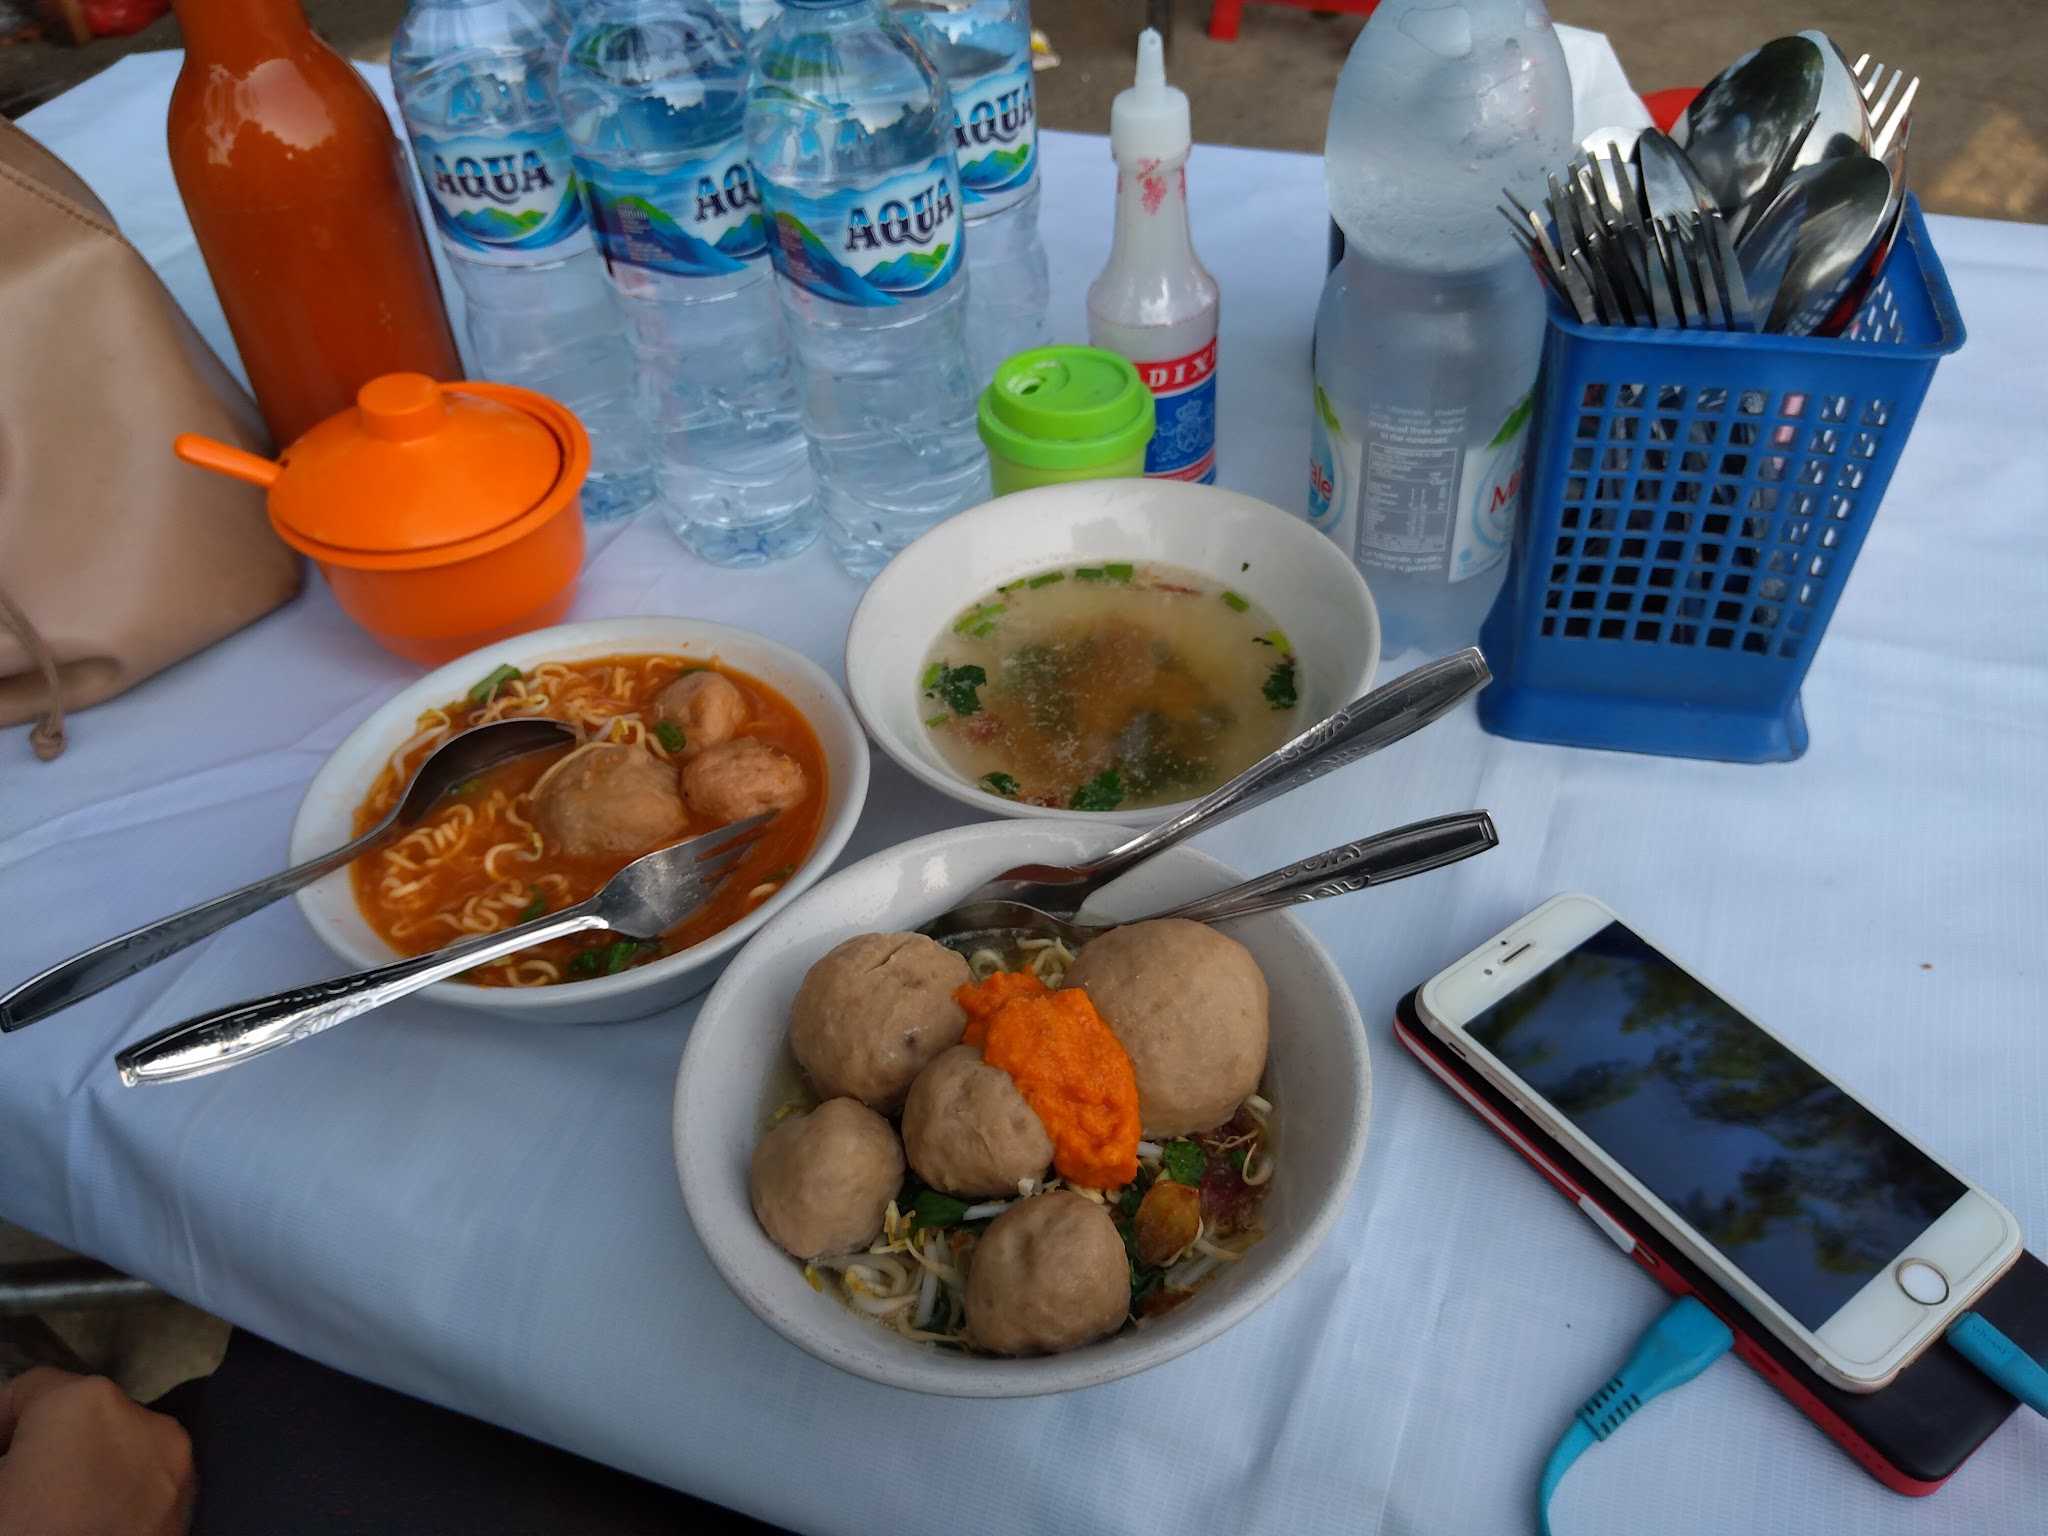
[918,811,1501,952]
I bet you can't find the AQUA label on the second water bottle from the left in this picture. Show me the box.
[575,137,768,276]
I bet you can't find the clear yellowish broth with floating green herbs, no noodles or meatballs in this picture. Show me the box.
[918,561,1300,811]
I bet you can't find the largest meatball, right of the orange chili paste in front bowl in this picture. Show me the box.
[1065,918,1268,1137]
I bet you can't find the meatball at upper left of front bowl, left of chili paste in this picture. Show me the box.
[788,934,975,1114]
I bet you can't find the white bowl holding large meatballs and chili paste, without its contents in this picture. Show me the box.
[674,819,1372,1397]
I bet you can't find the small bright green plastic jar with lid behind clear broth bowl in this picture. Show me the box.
[979,346,1153,496]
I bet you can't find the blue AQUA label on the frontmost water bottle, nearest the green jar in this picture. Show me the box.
[756,156,961,307]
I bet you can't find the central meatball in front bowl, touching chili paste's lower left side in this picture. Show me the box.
[903,1044,1053,1194]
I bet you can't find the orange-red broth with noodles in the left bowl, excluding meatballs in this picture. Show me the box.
[350,655,827,987]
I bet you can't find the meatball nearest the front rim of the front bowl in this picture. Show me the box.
[967,1190,1130,1354]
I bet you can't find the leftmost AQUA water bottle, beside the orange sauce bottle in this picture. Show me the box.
[391,0,653,520]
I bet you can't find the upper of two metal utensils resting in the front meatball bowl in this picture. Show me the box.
[937,645,1493,918]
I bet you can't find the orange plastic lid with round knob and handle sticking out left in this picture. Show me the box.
[176,373,565,555]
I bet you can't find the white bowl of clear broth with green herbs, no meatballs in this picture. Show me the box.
[846,479,1380,825]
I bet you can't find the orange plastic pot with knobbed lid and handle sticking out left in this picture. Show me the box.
[172,373,590,664]
